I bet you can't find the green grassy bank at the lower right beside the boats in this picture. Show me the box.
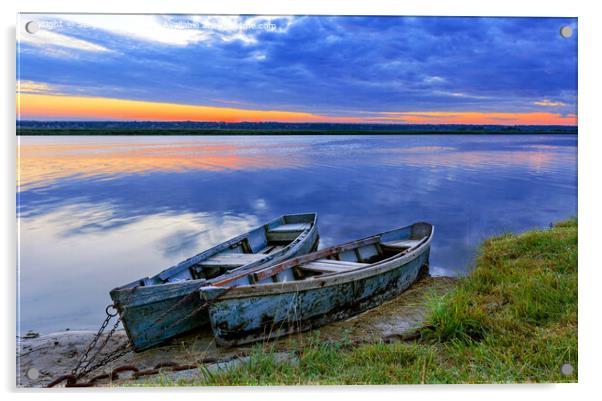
[146,220,577,385]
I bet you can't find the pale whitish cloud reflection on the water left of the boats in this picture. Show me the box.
[19,204,258,332]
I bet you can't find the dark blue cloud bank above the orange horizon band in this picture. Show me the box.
[19,16,577,116]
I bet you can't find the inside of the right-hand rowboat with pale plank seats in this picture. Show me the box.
[214,223,432,286]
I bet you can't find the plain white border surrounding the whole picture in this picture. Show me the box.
[0,0,602,401]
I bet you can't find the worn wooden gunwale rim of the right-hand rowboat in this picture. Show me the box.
[200,222,435,300]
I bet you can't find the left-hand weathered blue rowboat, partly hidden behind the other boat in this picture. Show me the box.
[110,213,318,351]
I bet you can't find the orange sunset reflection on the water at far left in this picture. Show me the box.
[17,142,306,190]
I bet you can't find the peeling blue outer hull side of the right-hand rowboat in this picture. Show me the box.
[205,244,430,347]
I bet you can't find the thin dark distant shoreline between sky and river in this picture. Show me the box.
[16,126,578,136]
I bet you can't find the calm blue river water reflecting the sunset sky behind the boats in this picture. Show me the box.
[17,135,577,333]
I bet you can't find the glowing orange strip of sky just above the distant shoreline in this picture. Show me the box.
[17,93,577,125]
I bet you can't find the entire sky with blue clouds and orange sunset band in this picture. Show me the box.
[17,14,578,125]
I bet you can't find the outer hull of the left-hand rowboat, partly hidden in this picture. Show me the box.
[111,216,319,351]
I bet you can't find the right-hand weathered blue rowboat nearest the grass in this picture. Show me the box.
[200,223,434,347]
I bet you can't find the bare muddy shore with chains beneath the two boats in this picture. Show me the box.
[17,276,456,387]
